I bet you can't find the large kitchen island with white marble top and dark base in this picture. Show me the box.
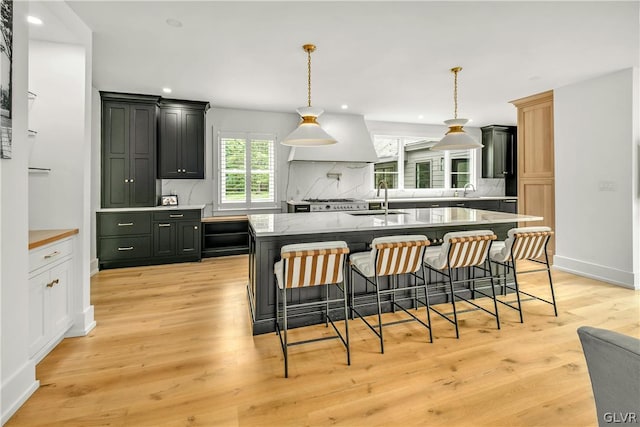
[247,208,542,335]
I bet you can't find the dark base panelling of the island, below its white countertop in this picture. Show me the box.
[247,222,515,334]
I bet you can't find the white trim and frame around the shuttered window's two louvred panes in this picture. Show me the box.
[215,131,280,211]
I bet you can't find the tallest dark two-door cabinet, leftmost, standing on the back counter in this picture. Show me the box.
[100,92,160,208]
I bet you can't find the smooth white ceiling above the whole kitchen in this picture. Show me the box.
[33,1,640,126]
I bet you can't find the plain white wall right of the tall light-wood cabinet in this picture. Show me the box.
[554,69,640,289]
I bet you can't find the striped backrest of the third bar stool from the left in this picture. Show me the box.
[440,230,497,268]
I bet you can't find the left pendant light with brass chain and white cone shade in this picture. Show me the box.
[281,44,338,147]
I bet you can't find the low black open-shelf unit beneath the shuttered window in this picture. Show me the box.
[202,216,249,257]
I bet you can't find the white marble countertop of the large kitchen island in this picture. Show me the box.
[248,208,542,237]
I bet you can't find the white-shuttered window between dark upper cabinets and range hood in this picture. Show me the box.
[218,133,276,209]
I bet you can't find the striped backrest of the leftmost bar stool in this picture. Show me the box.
[280,241,349,288]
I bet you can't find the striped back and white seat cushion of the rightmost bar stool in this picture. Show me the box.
[490,226,553,262]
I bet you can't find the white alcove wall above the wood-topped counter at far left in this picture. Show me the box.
[29,41,85,230]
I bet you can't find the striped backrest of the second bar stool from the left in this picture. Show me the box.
[371,235,429,276]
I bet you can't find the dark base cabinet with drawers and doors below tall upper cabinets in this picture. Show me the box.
[97,209,201,269]
